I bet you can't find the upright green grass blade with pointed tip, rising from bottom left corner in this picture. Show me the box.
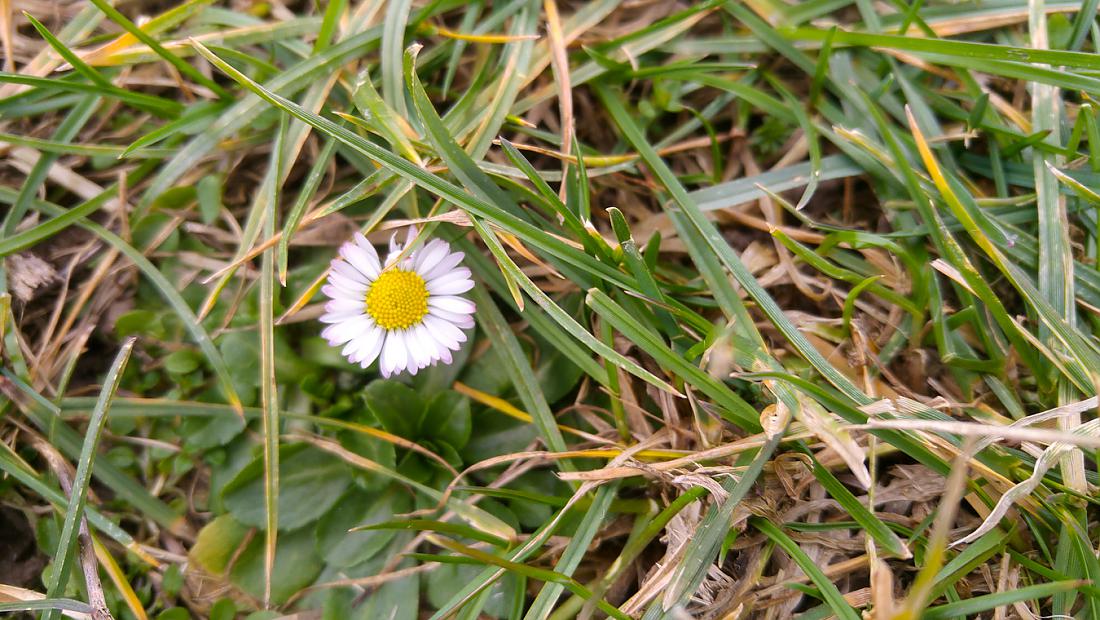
[46,339,136,620]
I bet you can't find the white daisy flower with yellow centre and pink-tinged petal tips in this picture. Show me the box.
[321,228,474,377]
